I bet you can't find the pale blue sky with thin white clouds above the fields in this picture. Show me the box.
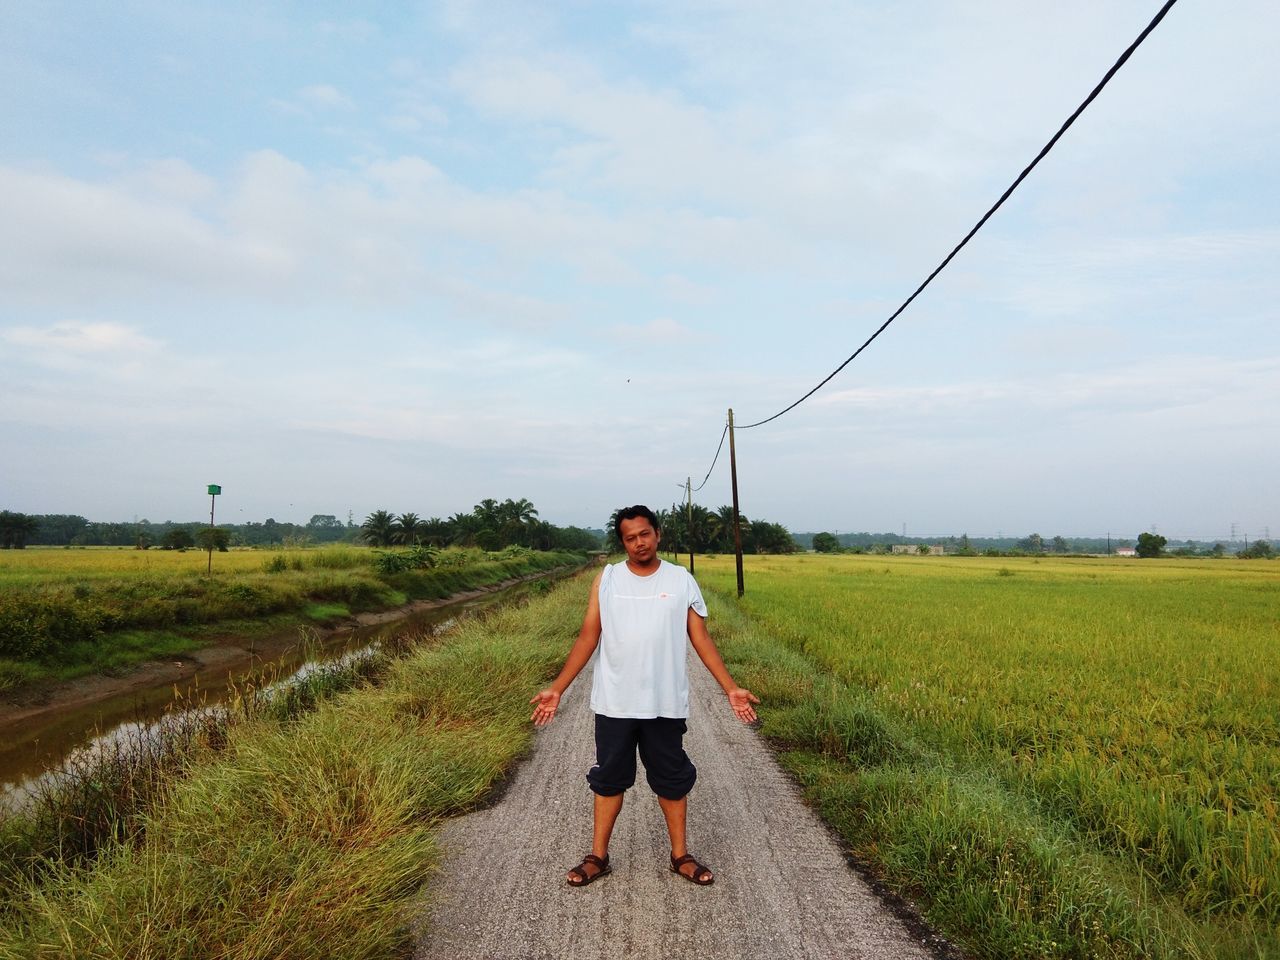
[0,0,1280,539]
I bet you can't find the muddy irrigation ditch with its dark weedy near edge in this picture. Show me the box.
[0,566,580,892]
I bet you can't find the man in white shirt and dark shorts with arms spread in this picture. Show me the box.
[530,506,759,887]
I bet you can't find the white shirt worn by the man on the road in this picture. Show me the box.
[591,561,707,719]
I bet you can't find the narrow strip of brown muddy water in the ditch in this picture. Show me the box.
[0,582,560,806]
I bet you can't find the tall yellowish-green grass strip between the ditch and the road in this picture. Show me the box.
[0,577,584,960]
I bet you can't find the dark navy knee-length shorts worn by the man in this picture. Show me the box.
[586,713,698,800]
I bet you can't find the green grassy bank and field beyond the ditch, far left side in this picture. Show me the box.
[0,548,581,691]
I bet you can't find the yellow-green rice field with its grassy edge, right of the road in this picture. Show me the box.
[698,556,1280,956]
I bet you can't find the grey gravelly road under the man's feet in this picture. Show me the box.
[415,658,934,960]
